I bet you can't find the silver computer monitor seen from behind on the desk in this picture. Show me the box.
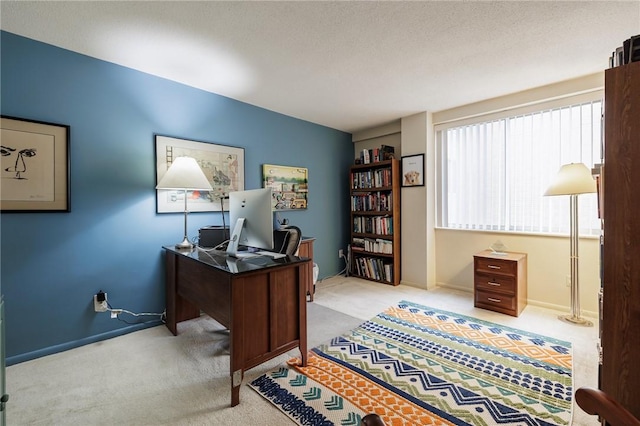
[227,188,273,257]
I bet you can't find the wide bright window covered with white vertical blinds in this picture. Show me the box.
[436,94,602,235]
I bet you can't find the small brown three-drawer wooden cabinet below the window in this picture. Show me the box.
[473,250,527,317]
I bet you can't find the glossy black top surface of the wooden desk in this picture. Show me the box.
[163,246,308,274]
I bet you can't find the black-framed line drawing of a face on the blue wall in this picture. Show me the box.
[0,116,71,212]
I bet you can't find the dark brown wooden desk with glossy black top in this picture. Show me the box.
[164,247,310,407]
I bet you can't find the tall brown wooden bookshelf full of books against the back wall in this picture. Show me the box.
[349,159,400,285]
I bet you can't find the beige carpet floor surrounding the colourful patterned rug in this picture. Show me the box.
[7,277,598,426]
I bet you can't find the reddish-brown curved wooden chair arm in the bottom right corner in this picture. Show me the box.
[576,386,640,426]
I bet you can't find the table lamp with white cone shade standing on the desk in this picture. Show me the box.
[156,157,213,249]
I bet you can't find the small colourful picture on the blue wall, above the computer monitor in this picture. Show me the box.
[262,164,309,210]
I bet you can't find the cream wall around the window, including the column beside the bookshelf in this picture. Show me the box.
[354,73,604,317]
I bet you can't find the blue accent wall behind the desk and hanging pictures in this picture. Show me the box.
[0,31,353,364]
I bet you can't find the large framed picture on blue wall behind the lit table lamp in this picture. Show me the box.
[155,135,244,213]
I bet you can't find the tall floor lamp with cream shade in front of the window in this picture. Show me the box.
[544,163,596,327]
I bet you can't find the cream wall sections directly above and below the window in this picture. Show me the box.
[432,73,604,317]
